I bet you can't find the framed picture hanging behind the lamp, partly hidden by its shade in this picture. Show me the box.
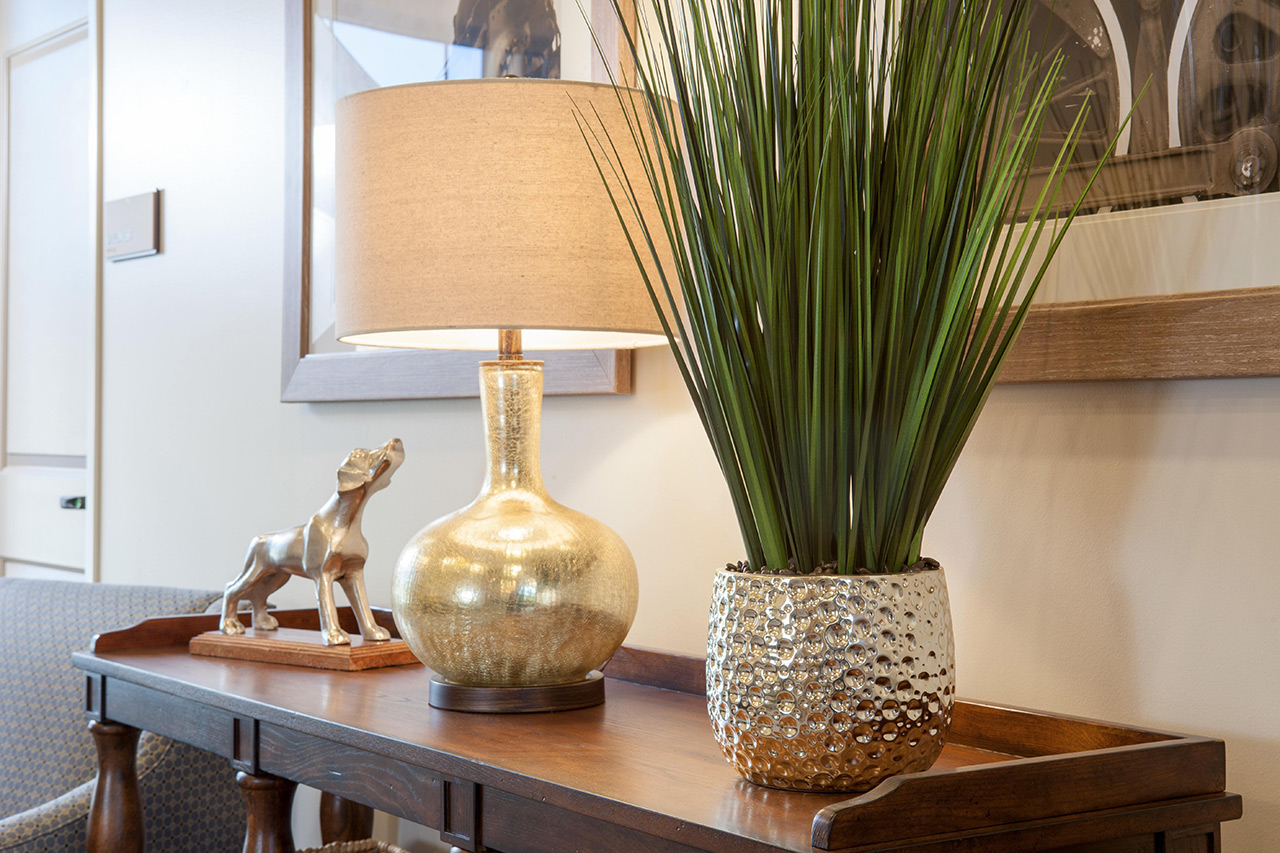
[280,0,635,402]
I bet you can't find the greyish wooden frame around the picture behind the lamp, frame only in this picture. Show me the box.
[280,0,634,402]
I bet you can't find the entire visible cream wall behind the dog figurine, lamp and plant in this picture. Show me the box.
[101,0,1280,853]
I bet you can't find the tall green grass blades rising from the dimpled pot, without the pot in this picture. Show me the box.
[581,0,1121,574]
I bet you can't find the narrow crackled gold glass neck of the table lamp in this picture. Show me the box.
[480,360,547,497]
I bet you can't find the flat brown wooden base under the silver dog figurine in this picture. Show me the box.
[188,628,419,672]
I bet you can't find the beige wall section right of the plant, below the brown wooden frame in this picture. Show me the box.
[927,379,1280,853]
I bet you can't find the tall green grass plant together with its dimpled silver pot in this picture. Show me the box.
[582,0,1126,790]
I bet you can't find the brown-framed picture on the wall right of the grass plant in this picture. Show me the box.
[1001,0,1280,382]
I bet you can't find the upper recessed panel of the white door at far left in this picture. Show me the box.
[5,27,93,456]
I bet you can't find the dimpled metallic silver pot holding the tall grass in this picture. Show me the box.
[707,569,955,792]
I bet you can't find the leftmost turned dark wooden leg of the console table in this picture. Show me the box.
[86,721,143,853]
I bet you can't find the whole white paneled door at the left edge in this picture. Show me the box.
[0,6,100,580]
